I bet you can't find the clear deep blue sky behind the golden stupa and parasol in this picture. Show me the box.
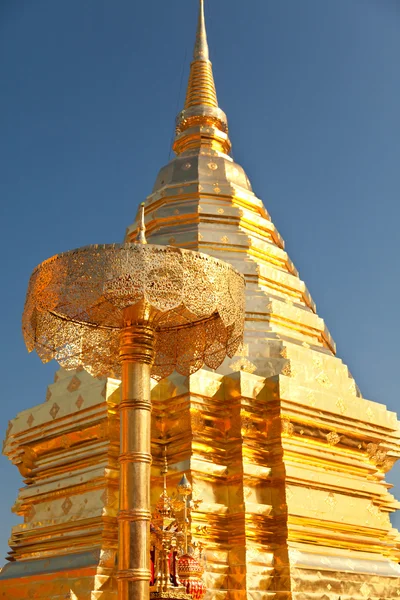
[0,0,400,556]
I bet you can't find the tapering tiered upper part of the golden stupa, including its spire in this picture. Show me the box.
[127,0,335,376]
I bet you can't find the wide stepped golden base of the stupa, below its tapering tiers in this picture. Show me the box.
[0,366,400,600]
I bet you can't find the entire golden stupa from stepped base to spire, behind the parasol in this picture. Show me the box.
[0,0,400,600]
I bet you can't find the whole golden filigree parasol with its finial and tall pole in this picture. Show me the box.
[23,208,244,600]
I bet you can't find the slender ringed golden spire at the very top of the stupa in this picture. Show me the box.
[173,0,231,154]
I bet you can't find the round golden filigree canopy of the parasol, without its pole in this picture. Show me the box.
[23,244,244,379]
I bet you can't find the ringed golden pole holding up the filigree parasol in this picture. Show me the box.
[118,313,155,600]
